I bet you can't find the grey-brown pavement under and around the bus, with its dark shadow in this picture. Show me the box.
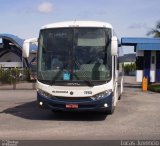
[0,77,160,140]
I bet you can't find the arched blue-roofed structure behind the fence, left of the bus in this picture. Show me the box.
[0,34,37,67]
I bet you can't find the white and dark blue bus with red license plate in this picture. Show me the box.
[23,21,123,114]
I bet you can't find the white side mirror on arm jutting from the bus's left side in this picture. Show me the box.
[22,38,38,58]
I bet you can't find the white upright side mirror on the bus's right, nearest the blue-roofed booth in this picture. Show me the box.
[111,36,118,56]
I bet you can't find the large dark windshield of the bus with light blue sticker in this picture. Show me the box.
[37,27,112,85]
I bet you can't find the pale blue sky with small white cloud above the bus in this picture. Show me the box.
[0,0,160,53]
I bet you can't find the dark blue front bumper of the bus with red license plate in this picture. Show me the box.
[37,92,113,111]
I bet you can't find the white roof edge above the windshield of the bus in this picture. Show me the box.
[41,21,112,29]
